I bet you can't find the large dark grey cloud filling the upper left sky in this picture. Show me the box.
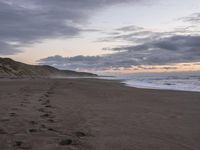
[0,0,138,55]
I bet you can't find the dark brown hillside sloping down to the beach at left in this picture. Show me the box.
[0,58,97,78]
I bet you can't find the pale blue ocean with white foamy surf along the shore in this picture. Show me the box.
[101,72,200,92]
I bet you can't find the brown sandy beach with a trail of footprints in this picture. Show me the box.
[0,79,200,150]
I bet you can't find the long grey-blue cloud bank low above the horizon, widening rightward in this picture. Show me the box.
[39,35,200,70]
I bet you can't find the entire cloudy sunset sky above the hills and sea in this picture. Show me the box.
[0,0,200,73]
